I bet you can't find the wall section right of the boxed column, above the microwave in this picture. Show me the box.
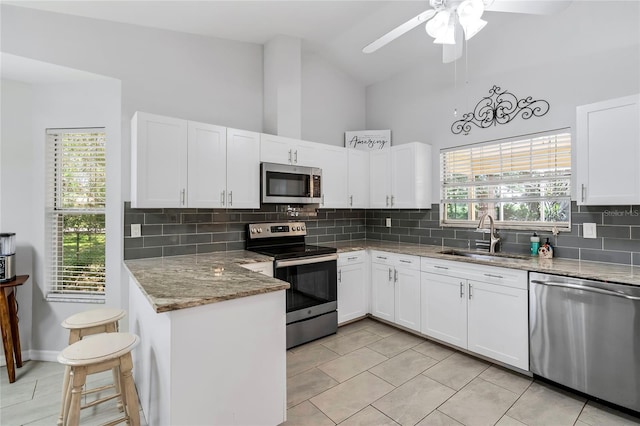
[302,53,366,146]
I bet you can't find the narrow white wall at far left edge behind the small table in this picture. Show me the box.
[0,80,36,364]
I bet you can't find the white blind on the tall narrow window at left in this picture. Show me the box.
[46,128,106,303]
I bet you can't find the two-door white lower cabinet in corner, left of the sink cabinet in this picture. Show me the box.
[371,252,420,331]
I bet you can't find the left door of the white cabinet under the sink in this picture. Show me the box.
[420,272,467,348]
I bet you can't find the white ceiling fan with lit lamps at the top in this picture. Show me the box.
[362,0,571,63]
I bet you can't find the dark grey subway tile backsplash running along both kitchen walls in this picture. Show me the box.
[124,202,640,265]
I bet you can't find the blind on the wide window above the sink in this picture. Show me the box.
[440,130,571,229]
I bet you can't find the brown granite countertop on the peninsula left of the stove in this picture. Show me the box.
[124,250,289,313]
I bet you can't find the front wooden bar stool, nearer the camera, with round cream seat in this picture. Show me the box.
[58,333,140,426]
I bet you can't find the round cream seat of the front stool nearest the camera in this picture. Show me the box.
[58,333,140,366]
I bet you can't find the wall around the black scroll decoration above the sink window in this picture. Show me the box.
[367,1,640,198]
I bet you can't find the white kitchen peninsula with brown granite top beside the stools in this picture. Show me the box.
[125,251,289,425]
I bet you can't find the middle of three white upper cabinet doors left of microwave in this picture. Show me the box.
[187,121,227,208]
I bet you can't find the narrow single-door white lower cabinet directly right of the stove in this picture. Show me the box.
[338,251,369,324]
